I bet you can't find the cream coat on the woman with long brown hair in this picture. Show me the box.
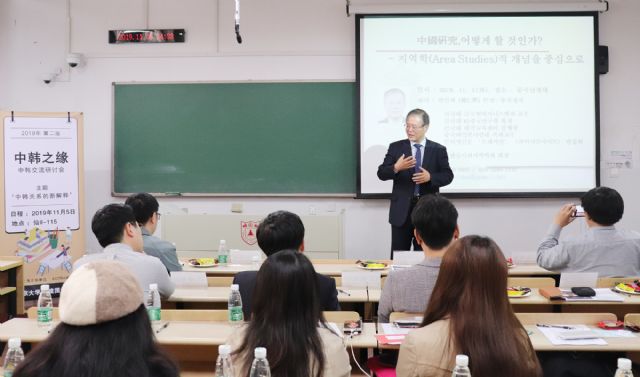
[396,319,456,377]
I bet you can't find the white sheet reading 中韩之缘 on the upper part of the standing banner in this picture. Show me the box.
[4,117,80,232]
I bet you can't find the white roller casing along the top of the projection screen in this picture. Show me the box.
[347,0,609,15]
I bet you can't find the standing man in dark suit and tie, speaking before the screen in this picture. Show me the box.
[378,109,453,257]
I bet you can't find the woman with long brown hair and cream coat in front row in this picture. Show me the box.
[396,236,542,377]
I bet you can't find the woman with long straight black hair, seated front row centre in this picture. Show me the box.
[229,250,351,377]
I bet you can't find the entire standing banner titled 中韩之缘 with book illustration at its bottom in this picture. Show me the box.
[0,112,85,299]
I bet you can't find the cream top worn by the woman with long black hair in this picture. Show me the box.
[227,326,351,377]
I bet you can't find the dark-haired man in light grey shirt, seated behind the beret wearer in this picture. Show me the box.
[73,204,175,298]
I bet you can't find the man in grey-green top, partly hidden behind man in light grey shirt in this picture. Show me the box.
[125,192,182,272]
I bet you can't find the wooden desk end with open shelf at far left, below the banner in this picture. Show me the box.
[0,257,24,322]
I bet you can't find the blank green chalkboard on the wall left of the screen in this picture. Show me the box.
[113,82,357,195]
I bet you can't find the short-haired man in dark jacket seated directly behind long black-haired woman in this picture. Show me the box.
[233,211,340,320]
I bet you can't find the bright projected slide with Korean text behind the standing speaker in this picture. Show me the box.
[358,14,597,196]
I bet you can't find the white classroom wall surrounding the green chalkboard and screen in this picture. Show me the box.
[0,0,640,259]
